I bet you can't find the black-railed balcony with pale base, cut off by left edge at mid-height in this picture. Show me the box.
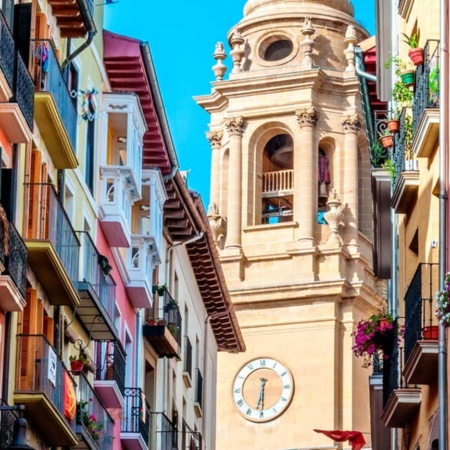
[0,209,27,311]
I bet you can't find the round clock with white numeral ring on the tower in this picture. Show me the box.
[233,358,294,422]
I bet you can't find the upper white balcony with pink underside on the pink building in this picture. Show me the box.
[99,166,139,247]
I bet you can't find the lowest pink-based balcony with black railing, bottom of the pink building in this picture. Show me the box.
[120,388,150,450]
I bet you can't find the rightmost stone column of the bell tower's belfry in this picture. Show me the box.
[342,114,361,245]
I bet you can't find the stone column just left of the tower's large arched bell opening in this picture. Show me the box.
[225,117,244,248]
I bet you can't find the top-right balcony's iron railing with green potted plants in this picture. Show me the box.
[413,39,440,131]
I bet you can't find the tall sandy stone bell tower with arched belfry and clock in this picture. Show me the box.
[196,0,380,450]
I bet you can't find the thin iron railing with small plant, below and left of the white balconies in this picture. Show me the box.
[76,231,116,323]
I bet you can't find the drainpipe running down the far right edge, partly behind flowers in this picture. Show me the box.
[438,0,449,450]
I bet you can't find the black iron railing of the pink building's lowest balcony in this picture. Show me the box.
[122,388,150,442]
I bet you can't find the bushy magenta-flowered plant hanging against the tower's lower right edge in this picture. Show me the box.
[352,313,396,367]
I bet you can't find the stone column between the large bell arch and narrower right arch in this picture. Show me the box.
[294,107,318,246]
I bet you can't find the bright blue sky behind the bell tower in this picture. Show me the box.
[103,0,375,208]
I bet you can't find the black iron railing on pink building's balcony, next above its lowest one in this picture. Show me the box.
[95,340,126,395]
